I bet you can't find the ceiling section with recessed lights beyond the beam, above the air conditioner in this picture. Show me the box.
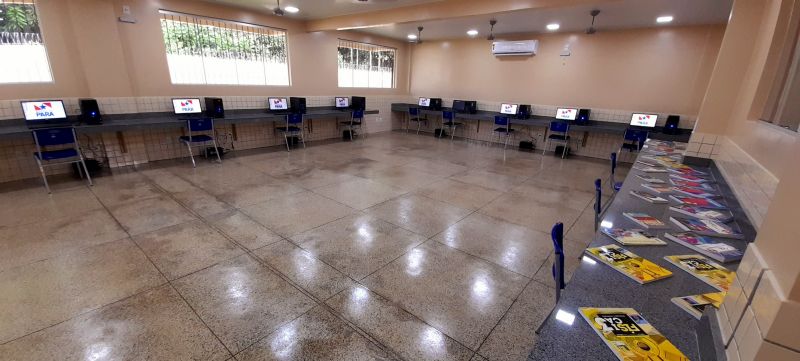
[360,0,733,40]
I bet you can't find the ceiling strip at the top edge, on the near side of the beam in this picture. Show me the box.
[200,0,442,20]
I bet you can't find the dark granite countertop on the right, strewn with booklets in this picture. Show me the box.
[529,141,755,360]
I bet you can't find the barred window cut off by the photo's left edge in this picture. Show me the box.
[0,0,53,84]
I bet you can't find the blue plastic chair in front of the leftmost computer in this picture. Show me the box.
[33,127,93,193]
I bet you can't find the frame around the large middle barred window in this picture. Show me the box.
[158,9,292,87]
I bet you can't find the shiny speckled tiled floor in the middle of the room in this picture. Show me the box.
[0,133,624,360]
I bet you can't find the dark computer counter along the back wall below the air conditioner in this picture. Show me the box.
[392,103,692,146]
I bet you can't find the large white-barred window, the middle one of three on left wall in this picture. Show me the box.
[161,10,290,85]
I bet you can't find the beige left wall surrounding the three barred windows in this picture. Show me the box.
[0,0,409,99]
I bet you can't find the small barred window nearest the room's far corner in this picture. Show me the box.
[338,39,397,88]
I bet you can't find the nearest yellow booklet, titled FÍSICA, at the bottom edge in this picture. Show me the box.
[580,307,689,361]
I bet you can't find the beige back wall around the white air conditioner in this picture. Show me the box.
[411,25,725,115]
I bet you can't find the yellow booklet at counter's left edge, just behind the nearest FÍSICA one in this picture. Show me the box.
[586,244,672,284]
